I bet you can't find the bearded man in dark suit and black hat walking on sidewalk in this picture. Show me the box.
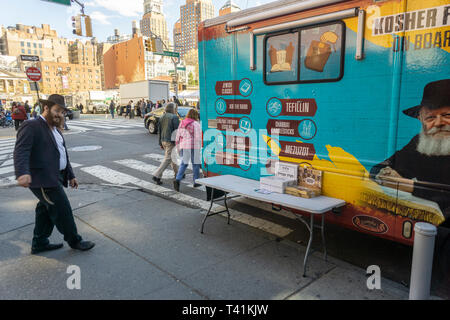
[14,94,95,254]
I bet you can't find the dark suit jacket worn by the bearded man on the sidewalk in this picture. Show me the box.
[14,117,75,188]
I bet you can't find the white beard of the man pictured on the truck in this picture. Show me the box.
[417,125,450,156]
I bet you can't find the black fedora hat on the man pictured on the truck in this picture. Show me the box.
[403,79,450,118]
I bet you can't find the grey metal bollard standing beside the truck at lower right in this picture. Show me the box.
[409,222,437,300]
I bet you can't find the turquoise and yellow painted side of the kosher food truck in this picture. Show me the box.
[199,0,450,244]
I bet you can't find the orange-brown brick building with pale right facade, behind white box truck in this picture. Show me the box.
[103,34,186,89]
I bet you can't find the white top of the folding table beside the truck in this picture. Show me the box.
[195,175,345,214]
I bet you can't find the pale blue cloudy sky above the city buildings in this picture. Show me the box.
[0,0,274,42]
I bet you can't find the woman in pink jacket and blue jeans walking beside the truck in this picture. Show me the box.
[173,109,202,191]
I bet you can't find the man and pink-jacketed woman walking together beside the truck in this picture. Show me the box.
[152,102,202,191]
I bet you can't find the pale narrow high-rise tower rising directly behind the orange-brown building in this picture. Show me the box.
[140,0,170,48]
